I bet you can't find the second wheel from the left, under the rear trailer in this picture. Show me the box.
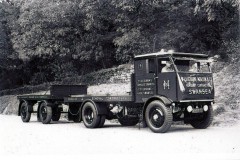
[39,102,52,124]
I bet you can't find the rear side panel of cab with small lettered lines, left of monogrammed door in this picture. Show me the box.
[134,58,157,103]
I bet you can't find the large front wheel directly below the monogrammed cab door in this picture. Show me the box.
[145,100,173,133]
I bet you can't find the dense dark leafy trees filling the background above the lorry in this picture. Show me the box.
[0,0,240,90]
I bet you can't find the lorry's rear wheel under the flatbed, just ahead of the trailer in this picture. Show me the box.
[82,102,101,128]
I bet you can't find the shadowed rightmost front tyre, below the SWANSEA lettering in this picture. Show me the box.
[190,105,213,129]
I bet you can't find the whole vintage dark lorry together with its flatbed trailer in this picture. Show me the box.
[18,51,214,133]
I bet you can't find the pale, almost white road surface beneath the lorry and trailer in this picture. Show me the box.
[0,115,240,159]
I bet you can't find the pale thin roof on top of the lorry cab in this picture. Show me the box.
[134,51,208,59]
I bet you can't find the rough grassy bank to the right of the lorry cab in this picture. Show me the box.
[214,62,240,125]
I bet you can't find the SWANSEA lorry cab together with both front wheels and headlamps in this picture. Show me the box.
[133,51,214,133]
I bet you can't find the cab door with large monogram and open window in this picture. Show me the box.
[157,58,177,101]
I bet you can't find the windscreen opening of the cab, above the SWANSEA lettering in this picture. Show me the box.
[174,59,210,73]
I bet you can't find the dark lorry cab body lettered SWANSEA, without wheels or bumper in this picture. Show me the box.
[134,52,214,103]
